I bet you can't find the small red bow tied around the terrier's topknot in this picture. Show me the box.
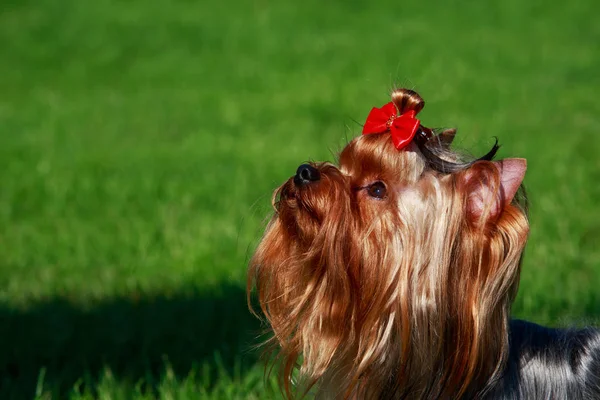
[363,102,421,150]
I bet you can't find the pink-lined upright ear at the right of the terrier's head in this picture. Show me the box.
[459,158,527,221]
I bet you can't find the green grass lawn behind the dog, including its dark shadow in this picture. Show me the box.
[0,0,600,399]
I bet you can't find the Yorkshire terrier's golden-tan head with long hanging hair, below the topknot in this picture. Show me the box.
[249,99,528,398]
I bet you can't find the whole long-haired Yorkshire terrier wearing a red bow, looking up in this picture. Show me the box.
[248,89,600,400]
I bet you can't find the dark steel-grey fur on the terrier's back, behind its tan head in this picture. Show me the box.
[486,320,600,400]
